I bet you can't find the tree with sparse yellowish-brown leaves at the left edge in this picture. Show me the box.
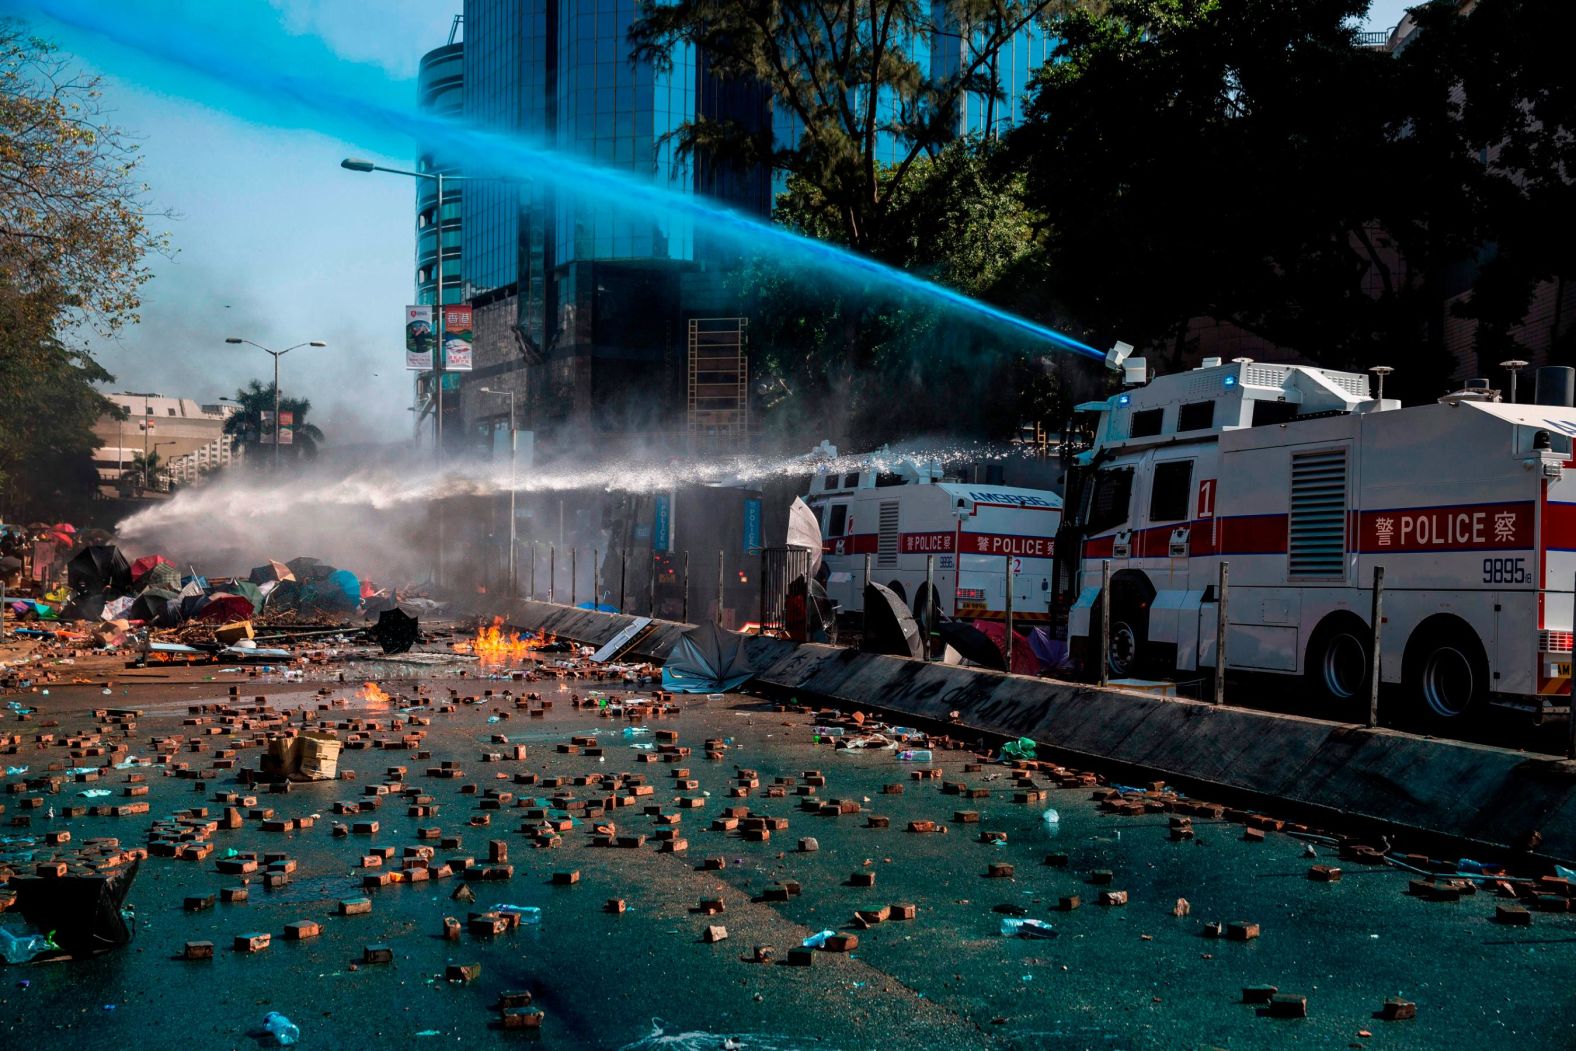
[0,20,162,518]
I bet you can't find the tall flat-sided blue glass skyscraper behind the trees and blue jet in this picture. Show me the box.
[435,0,1054,444]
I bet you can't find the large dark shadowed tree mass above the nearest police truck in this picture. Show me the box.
[1010,0,1571,397]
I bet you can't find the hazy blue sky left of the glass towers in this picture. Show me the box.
[12,0,1407,443]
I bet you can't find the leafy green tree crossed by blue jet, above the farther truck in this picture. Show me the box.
[736,139,1077,448]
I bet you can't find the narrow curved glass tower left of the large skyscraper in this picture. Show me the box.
[416,44,465,303]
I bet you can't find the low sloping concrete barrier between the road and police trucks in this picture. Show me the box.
[514,602,1576,860]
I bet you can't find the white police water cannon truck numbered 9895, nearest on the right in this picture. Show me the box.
[1054,345,1576,723]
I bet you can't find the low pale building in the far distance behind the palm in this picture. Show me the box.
[93,392,243,496]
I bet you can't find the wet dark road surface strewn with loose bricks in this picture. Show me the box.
[0,665,1576,1049]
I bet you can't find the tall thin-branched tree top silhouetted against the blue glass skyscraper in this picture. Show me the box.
[629,0,1083,254]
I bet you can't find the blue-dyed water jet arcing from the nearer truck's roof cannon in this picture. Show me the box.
[15,0,1105,358]
